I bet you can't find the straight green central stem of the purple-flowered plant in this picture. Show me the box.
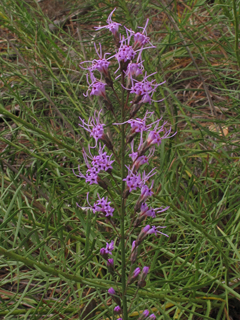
[120,72,128,320]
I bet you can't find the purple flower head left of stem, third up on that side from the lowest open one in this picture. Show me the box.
[78,109,105,145]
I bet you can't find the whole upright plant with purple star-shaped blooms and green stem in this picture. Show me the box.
[75,9,174,320]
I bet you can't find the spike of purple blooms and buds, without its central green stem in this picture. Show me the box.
[74,9,174,320]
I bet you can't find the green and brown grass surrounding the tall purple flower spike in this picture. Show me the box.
[0,0,240,320]
